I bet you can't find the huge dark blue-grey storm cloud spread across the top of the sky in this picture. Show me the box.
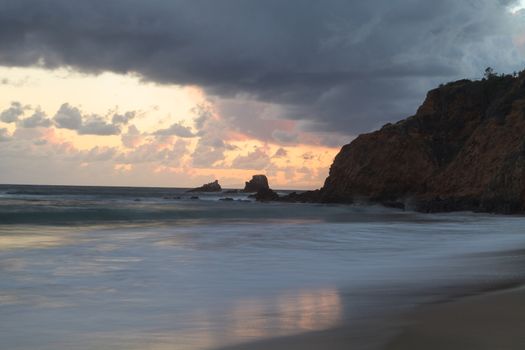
[0,0,523,133]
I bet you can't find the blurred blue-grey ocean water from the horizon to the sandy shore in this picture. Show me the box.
[0,185,525,350]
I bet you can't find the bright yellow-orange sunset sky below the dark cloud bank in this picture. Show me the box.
[0,68,339,188]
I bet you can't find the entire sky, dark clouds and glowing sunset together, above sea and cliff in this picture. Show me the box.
[0,0,525,189]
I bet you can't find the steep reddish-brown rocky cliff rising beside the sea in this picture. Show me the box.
[320,74,525,213]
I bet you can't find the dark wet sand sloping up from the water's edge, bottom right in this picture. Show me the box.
[217,288,525,350]
